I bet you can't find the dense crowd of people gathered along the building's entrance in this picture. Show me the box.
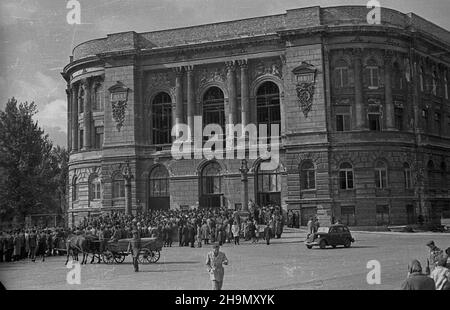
[0,201,284,262]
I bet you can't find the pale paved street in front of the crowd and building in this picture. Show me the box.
[0,229,450,290]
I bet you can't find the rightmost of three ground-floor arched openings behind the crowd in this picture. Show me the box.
[256,164,281,206]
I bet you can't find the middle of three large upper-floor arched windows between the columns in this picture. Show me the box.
[203,87,225,133]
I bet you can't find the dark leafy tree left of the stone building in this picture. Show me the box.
[0,98,65,226]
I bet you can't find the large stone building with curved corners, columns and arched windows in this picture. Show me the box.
[63,6,450,226]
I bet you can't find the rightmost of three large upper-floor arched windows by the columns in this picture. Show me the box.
[256,82,281,137]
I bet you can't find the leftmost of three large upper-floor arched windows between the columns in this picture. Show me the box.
[152,93,172,144]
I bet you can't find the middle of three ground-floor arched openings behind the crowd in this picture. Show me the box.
[200,162,223,208]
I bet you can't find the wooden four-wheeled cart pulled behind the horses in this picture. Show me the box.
[102,238,163,264]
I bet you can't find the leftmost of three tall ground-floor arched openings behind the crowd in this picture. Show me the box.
[149,166,170,210]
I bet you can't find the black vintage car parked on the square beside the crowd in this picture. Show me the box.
[305,224,355,249]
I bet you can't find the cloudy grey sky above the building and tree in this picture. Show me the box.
[0,0,450,146]
